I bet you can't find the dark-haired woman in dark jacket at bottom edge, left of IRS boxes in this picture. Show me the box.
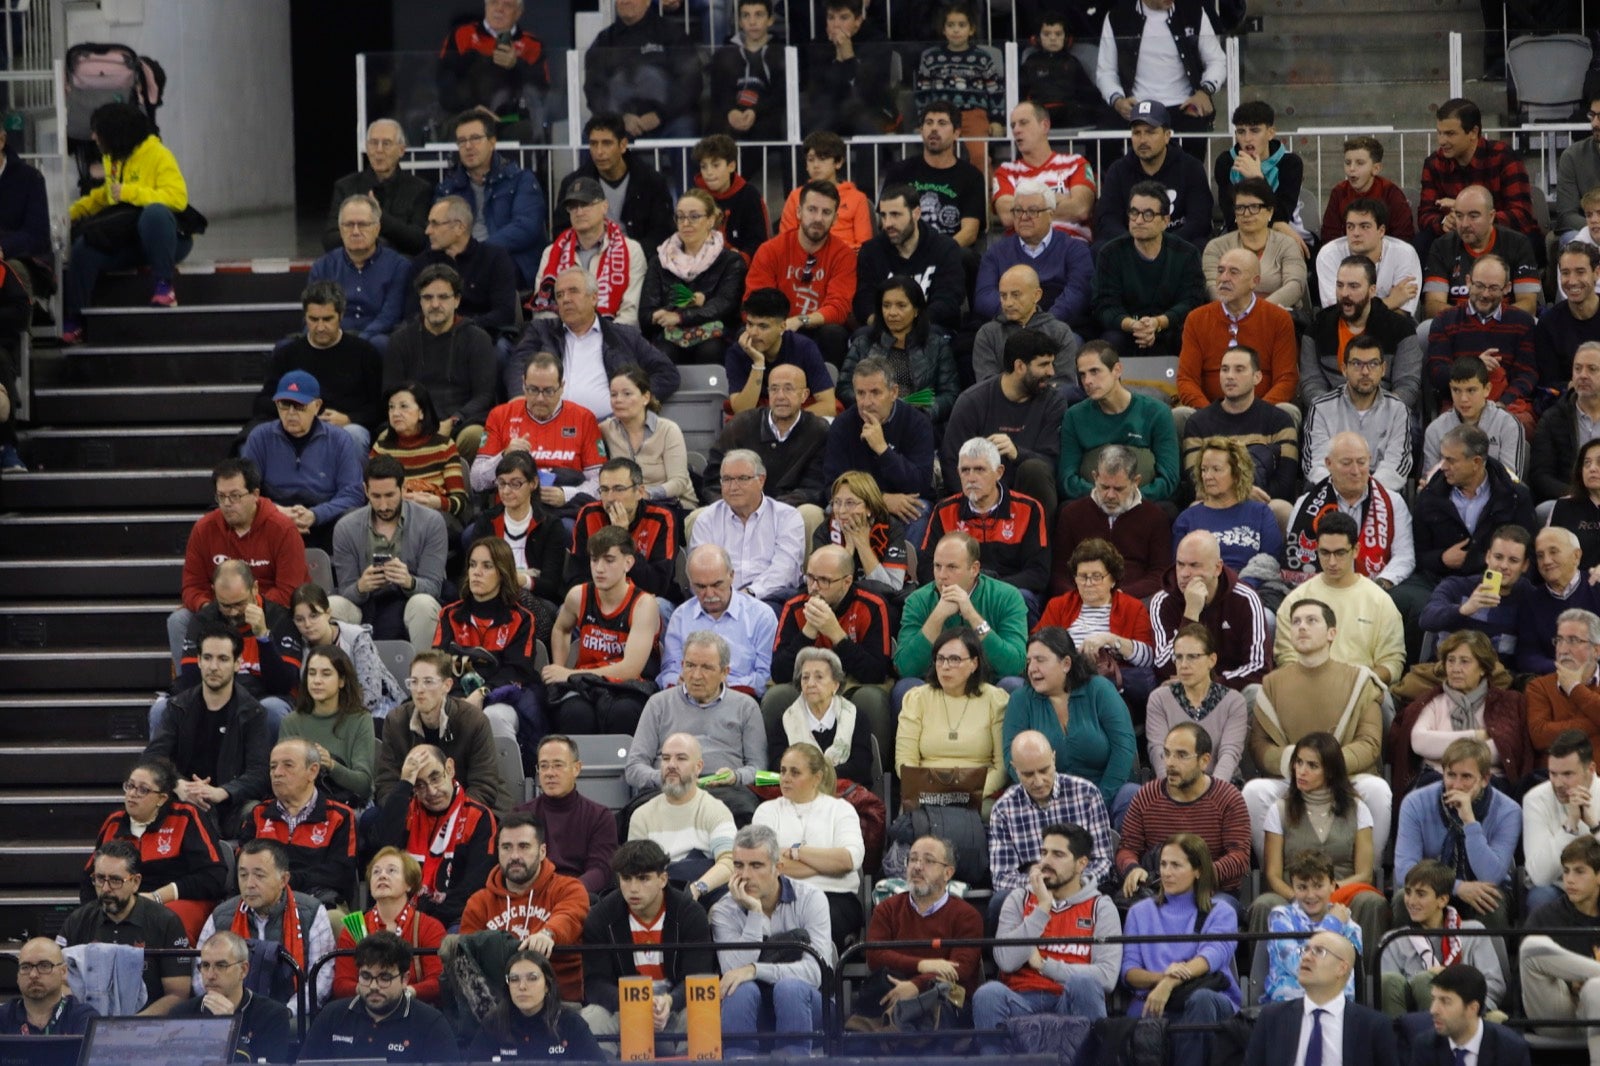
[467,948,606,1063]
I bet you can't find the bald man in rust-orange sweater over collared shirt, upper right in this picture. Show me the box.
[1178,248,1299,412]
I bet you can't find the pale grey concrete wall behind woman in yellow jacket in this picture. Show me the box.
[66,0,297,218]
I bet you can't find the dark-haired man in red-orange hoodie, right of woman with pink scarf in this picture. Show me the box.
[744,181,857,367]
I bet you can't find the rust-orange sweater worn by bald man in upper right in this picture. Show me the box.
[1178,296,1299,407]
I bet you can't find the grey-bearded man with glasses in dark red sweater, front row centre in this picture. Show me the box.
[845,836,984,1032]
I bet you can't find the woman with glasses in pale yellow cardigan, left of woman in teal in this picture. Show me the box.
[894,626,1006,795]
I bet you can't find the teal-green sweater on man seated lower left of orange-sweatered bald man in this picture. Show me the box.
[1056,392,1179,499]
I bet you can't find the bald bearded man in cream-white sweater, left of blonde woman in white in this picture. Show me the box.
[627,733,734,900]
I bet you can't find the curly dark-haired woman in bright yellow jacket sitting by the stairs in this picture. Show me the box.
[61,104,194,344]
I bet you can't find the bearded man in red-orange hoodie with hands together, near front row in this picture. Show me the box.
[461,812,589,1004]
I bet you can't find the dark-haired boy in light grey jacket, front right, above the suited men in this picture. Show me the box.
[1379,860,1506,1021]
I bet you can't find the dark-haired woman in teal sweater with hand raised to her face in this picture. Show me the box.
[1000,626,1139,813]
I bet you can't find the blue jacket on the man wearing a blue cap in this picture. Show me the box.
[242,421,366,525]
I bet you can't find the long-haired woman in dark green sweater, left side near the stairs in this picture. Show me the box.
[278,645,373,810]
